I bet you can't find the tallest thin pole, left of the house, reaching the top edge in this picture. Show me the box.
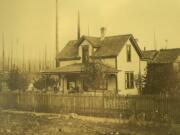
[56,0,59,67]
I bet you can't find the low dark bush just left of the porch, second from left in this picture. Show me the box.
[33,75,56,90]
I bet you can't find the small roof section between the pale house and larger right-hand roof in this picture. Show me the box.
[142,50,158,60]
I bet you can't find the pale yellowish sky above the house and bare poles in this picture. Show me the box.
[0,0,180,63]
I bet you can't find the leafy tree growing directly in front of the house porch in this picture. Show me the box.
[84,58,106,89]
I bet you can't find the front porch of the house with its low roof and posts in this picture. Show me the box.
[41,63,118,94]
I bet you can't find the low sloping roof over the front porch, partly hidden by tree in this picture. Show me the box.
[41,63,118,74]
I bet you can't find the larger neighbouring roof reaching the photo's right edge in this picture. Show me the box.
[153,48,180,63]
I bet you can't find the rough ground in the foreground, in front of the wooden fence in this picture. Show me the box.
[0,110,179,135]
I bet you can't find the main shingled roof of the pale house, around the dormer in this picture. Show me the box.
[57,34,142,60]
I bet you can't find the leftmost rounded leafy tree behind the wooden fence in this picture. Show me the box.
[7,69,29,91]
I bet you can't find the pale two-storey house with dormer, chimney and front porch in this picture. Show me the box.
[46,28,143,95]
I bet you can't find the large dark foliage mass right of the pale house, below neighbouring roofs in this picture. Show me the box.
[142,63,180,95]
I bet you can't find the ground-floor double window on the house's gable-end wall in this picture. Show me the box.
[125,72,134,89]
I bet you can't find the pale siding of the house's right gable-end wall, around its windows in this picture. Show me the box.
[117,40,140,95]
